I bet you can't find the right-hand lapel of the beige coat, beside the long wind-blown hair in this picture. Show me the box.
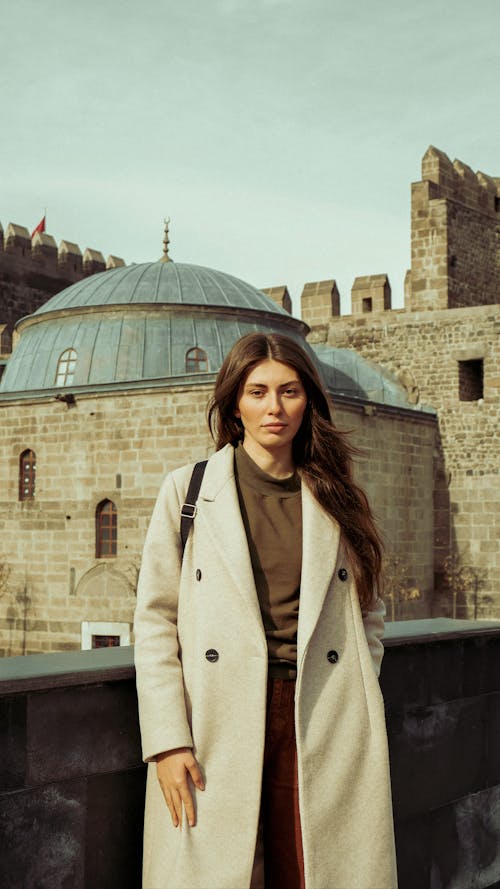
[297,482,340,666]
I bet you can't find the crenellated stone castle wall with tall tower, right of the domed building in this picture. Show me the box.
[302,147,500,617]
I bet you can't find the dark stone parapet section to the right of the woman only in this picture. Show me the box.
[381,618,500,889]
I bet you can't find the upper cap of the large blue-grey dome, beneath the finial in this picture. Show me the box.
[34,260,288,317]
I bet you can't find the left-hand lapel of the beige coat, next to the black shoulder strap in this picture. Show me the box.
[198,445,264,636]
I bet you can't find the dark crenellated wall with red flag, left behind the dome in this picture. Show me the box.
[0,222,125,356]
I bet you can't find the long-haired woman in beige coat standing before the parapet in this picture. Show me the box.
[135,333,396,889]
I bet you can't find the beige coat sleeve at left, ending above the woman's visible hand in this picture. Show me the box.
[134,473,193,762]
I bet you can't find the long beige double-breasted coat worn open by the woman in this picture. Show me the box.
[135,445,396,889]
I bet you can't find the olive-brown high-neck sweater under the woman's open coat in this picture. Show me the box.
[235,444,302,679]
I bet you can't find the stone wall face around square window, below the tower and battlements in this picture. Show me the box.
[310,306,500,617]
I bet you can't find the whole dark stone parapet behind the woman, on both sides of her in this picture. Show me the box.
[0,619,500,889]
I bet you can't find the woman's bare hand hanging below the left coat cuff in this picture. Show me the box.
[156,747,205,828]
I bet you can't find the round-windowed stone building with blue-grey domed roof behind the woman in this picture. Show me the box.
[0,234,436,654]
